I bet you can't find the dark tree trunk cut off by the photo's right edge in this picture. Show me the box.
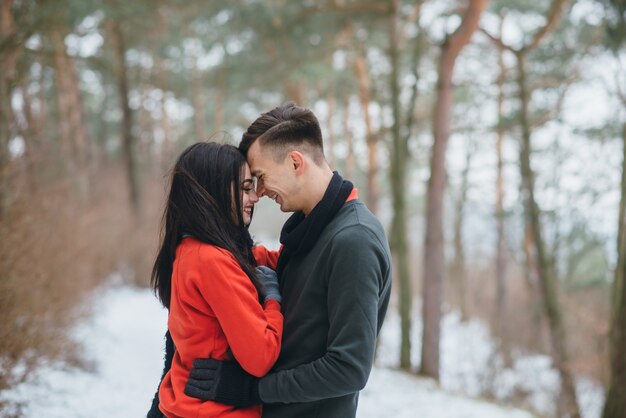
[602,123,626,418]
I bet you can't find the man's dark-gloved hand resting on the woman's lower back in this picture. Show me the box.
[185,358,262,408]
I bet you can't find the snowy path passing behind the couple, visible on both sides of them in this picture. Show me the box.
[0,287,532,418]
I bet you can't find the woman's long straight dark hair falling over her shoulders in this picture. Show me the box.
[151,142,261,309]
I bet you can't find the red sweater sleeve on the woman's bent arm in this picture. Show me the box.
[194,248,283,377]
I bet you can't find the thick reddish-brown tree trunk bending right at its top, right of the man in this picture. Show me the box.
[421,0,487,381]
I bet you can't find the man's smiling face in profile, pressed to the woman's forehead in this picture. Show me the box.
[248,141,301,212]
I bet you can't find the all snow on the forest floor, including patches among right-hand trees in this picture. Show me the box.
[0,280,602,418]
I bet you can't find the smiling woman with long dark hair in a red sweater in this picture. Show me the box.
[151,143,283,418]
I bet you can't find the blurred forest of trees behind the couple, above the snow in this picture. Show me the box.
[0,0,626,417]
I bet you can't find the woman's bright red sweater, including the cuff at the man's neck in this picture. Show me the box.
[159,237,283,418]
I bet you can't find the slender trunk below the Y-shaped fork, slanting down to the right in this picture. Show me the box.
[517,53,580,418]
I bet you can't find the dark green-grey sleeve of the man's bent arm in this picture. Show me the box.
[259,225,390,403]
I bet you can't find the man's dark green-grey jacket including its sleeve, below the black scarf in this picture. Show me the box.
[259,200,391,418]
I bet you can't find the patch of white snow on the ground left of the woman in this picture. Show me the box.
[0,280,167,418]
